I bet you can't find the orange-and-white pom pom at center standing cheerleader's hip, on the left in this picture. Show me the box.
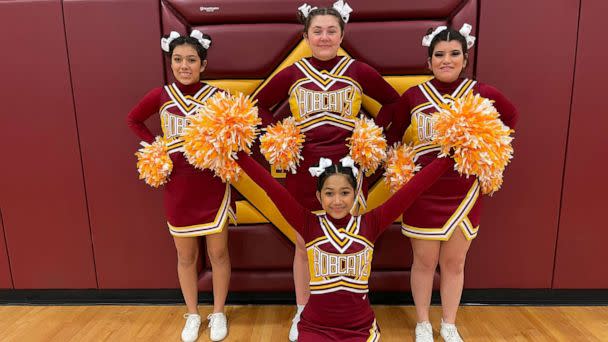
[260,117,304,173]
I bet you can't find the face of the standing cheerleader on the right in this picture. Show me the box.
[428,40,467,83]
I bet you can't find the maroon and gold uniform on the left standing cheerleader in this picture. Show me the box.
[127,83,235,237]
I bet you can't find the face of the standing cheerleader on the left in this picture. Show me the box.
[171,44,207,85]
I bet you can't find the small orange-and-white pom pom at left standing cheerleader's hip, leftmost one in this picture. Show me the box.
[135,137,173,188]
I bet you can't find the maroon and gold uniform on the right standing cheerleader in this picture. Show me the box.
[389,79,518,241]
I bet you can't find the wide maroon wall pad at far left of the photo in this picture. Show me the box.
[0,0,97,289]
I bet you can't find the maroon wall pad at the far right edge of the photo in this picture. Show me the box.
[553,0,608,289]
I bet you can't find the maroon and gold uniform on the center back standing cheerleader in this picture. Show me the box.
[255,56,399,210]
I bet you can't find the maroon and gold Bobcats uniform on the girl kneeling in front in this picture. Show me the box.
[238,153,454,342]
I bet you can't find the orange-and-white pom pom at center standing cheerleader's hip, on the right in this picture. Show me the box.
[347,117,386,172]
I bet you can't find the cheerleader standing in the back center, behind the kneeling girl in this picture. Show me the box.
[255,1,399,341]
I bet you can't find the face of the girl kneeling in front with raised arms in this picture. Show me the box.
[317,173,355,219]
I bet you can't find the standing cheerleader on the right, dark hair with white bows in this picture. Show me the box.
[387,24,518,342]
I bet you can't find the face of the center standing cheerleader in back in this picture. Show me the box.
[304,15,344,61]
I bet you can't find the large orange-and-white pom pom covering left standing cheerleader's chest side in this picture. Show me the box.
[183,92,261,182]
